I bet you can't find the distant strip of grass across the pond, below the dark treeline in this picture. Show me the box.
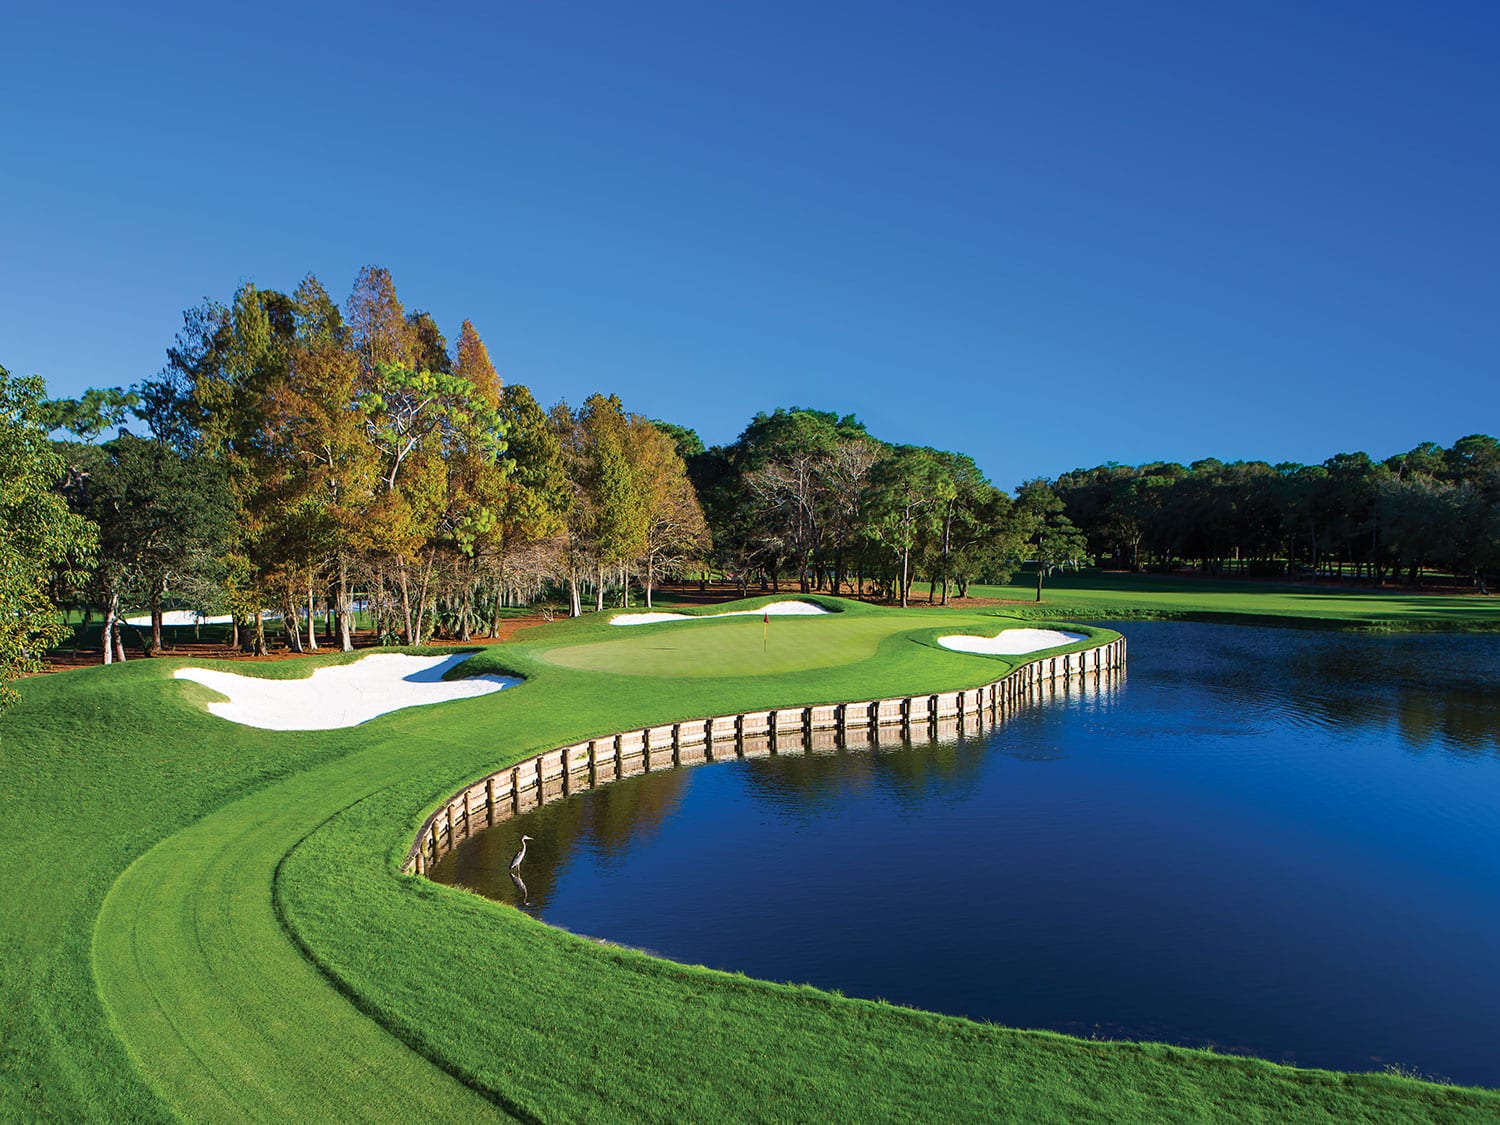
[920,570,1500,630]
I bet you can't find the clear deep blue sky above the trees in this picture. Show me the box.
[0,0,1500,486]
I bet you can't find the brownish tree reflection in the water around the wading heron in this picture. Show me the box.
[431,770,687,912]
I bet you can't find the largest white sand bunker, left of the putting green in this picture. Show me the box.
[176,653,521,731]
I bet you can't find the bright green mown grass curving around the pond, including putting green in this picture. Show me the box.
[0,596,1500,1121]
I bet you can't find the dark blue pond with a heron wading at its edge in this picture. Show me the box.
[432,623,1500,1086]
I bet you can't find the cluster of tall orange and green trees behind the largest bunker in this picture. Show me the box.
[32,267,708,663]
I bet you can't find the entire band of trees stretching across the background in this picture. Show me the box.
[0,266,1500,702]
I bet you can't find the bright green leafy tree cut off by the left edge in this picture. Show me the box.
[0,368,98,710]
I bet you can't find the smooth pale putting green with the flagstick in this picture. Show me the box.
[545,614,894,678]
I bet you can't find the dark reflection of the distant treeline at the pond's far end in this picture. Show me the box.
[1134,626,1500,756]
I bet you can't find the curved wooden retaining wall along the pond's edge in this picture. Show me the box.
[401,638,1125,875]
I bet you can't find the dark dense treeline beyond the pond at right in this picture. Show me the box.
[1055,444,1500,593]
